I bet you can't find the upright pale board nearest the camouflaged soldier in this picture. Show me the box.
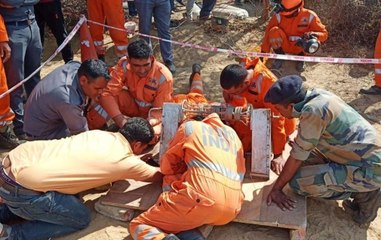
[250,109,271,180]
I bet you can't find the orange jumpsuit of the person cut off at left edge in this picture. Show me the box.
[0,15,15,127]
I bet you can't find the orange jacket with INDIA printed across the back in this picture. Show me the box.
[160,113,245,203]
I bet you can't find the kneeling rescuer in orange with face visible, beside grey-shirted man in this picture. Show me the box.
[87,39,173,138]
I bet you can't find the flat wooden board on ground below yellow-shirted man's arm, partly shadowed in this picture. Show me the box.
[100,180,162,211]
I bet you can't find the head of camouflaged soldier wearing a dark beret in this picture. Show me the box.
[265,75,307,118]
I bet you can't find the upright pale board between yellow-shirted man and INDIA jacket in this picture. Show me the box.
[159,103,183,164]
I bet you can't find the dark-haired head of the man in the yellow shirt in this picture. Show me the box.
[119,117,154,154]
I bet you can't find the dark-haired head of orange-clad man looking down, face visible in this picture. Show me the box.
[127,39,154,78]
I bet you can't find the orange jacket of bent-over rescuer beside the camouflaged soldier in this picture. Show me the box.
[224,58,287,155]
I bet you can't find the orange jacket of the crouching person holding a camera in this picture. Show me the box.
[261,8,328,52]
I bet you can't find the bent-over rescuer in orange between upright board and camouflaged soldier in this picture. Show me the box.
[220,58,296,174]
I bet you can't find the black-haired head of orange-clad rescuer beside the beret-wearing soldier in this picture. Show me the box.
[220,64,250,94]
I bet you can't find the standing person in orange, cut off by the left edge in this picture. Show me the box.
[0,15,20,149]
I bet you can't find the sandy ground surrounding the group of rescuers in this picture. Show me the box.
[8,1,381,240]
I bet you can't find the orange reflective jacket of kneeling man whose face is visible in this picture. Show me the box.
[102,57,173,118]
